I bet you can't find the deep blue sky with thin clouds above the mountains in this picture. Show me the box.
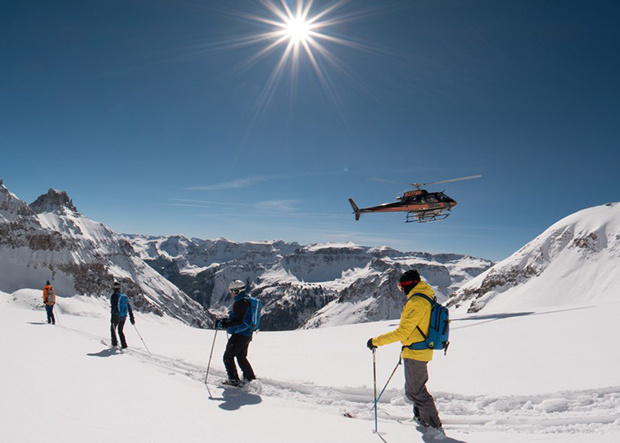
[0,0,620,260]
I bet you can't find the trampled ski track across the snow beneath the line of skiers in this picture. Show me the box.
[60,325,620,435]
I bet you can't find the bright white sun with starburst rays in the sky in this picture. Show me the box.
[214,0,371,113]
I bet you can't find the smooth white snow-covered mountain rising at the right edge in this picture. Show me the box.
[449,203,620,312]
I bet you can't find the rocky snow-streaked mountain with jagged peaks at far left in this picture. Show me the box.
[0,180,205,325]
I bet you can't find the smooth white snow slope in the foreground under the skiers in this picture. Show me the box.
[0,290,620,443]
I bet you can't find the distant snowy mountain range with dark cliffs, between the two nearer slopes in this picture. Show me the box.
[126,235,492,330]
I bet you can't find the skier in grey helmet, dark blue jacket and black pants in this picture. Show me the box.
[216,280,256,386]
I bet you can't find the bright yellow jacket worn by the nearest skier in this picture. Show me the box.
[372,281,435,361]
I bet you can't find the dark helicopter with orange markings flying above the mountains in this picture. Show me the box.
[349,175,482,223]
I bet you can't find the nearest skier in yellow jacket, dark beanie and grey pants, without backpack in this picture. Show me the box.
[366,269,445,438]
